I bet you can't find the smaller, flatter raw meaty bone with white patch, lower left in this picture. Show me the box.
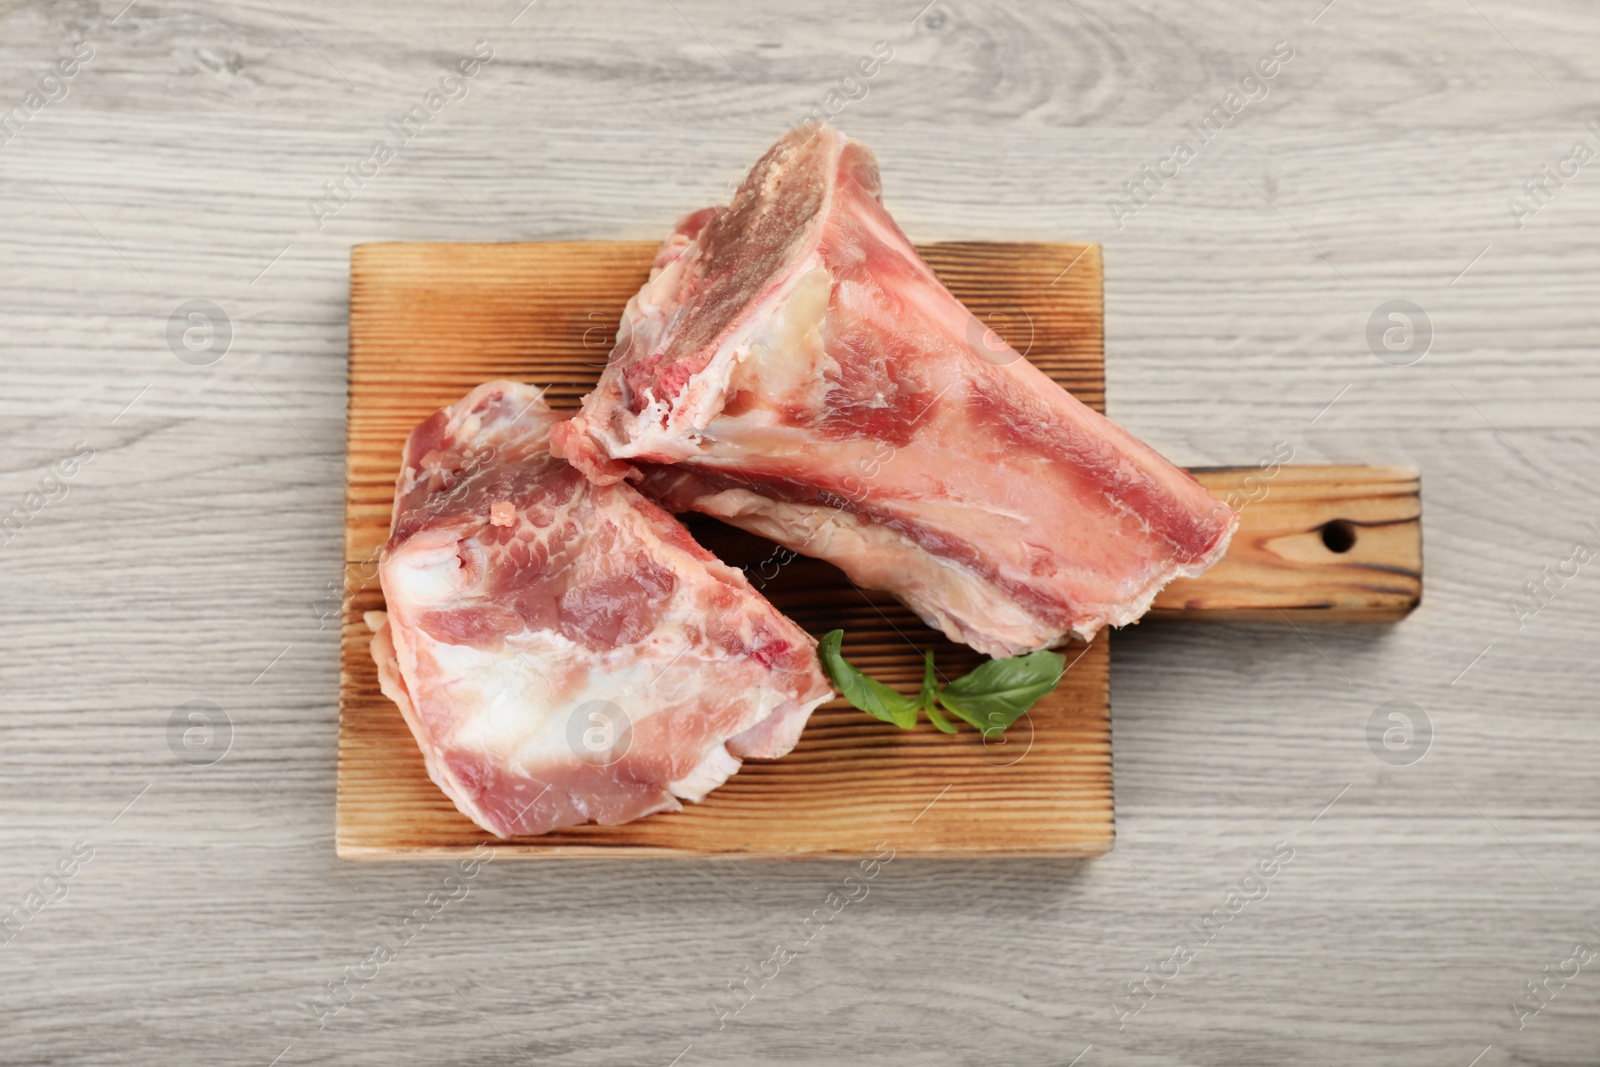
[370,382,832,837]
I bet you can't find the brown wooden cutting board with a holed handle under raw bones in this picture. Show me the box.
[338,242,1421,859]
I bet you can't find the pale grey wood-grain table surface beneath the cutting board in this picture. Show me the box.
[0,0,1600,1067]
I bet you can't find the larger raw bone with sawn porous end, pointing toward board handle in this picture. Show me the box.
[554,125,1237,656]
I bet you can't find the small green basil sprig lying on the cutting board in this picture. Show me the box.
[818,630,1067,737]
